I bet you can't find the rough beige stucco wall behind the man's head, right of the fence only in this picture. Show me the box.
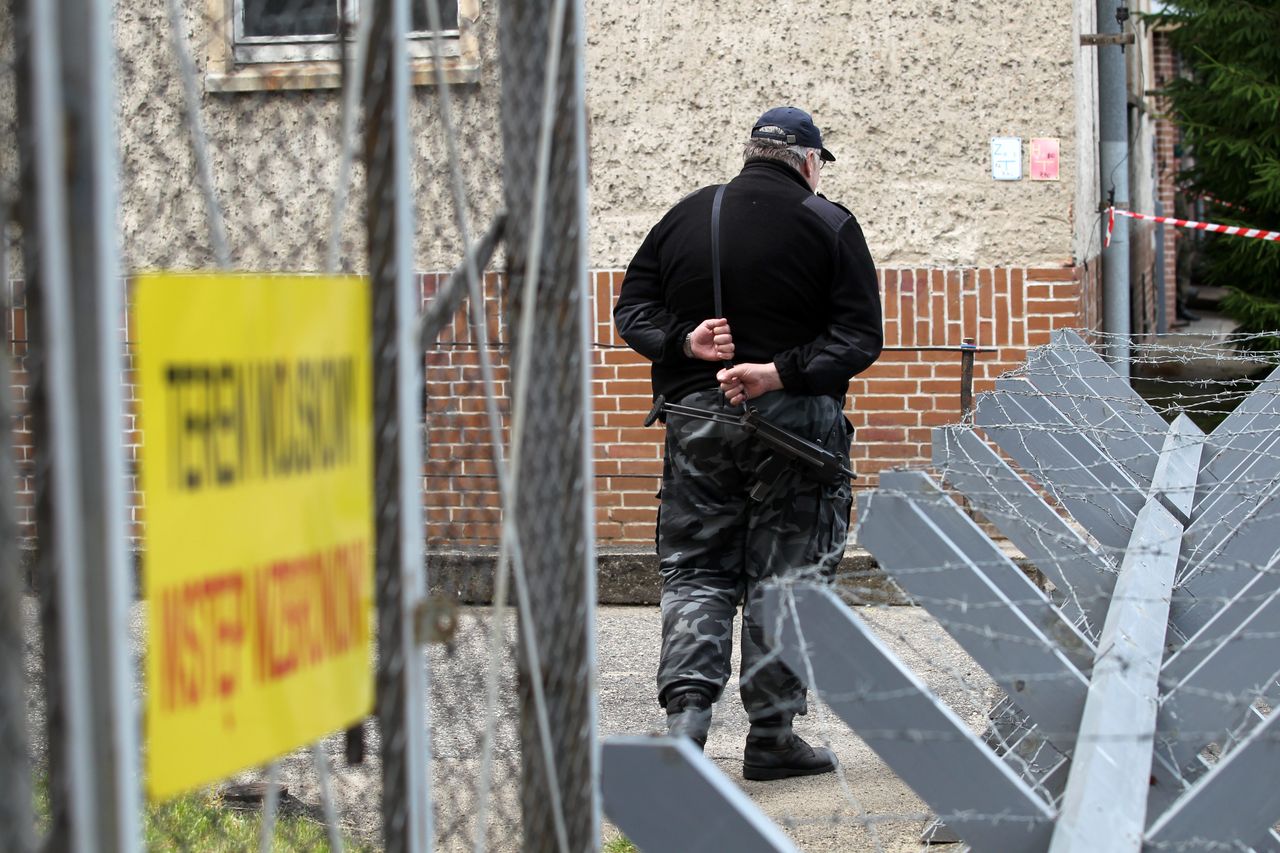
[588,0,1076,265]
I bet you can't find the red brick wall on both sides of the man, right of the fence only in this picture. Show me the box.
[591,263,1101,544]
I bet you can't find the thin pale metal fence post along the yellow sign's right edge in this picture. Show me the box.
[364,0,431,853]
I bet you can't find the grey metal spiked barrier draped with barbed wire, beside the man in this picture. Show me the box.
[605,333,1280,852]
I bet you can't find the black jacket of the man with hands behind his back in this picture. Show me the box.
[613,160,884,405]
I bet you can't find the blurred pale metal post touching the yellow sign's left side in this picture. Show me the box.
[58,0,142,850]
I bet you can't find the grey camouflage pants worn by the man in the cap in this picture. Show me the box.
[658,389,851,720]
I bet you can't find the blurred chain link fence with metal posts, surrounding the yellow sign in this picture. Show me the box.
[0,0,598,850]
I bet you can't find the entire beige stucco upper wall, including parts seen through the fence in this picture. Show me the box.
[118,0,1096,269]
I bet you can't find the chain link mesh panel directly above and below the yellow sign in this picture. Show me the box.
[115,0,383,849]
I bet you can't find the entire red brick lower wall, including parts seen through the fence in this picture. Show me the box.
[6,263,1101,548]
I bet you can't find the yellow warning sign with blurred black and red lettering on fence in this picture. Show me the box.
[134,274,372,799]
